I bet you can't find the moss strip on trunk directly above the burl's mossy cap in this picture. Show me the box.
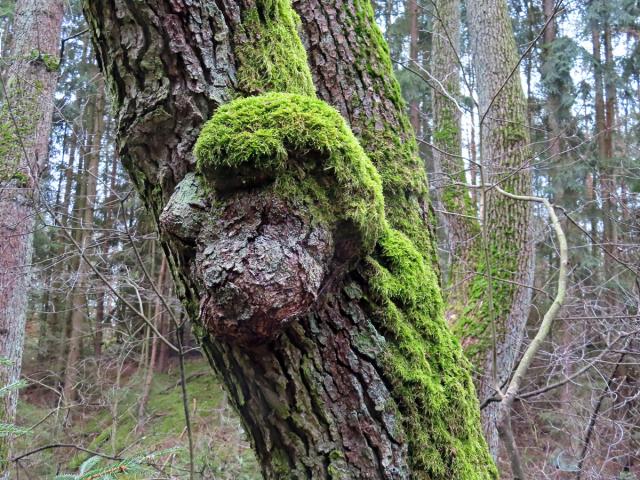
[236,0,315,96]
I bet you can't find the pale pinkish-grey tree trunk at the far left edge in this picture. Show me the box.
[0,0,63,472]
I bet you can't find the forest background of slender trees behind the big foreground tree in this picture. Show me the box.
[0,0,640,480]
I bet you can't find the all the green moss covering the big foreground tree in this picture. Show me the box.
[195,0,497,480]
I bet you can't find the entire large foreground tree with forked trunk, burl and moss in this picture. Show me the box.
[84,0,496,480]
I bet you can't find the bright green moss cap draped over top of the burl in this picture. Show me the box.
[195,93,384,251]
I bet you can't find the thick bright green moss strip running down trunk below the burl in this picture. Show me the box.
[369,228,497,480]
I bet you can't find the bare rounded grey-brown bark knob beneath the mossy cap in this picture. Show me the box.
[196,191,334,344]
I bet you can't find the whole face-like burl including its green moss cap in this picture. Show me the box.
[161,93,386,345]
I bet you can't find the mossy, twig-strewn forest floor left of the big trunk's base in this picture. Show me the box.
[13,350,261,480]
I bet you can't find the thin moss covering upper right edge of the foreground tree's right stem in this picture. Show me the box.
[336,0,437,265]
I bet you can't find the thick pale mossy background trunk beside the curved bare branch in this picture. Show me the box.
[458,0,534,454]
